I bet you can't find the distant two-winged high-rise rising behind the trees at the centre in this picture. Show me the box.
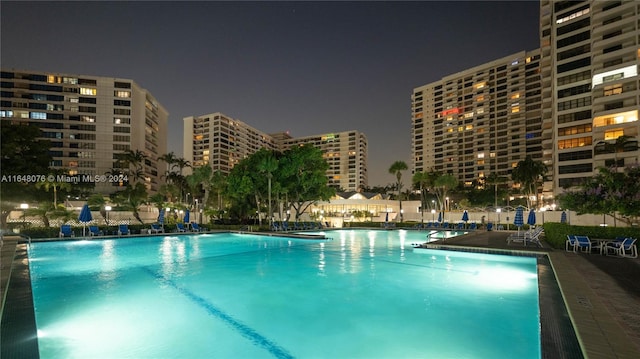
[183,112,367,191]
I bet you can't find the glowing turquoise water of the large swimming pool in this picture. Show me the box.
[29,230,541,359]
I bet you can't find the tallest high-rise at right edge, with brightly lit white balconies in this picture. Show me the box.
[540,0,640,194]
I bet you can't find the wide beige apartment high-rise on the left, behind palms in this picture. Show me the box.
[0,69,168,194]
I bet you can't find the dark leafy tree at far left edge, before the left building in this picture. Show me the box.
[0,119,52,228]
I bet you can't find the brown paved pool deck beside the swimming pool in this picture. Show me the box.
[0,231,640,359]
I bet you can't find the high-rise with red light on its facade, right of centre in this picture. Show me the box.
[411,50,542,193]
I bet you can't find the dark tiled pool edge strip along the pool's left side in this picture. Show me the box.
[0,243,40,359]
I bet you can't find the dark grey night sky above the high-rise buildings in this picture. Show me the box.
[0,0,539,186]
